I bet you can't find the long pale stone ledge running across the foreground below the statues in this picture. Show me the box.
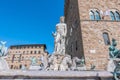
[0,70,114,80]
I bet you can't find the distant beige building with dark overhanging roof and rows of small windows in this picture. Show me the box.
[6,44,48,69]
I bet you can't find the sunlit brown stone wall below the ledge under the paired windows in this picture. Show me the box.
[81,21,120,70]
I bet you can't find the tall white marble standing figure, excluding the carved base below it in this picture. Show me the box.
[53,17,67,54]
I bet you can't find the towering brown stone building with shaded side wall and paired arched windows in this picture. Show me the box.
[64,0,120,70]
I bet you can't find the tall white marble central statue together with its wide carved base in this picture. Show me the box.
[47,17,85,71]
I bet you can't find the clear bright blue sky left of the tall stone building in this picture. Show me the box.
[0,0,64,53]
